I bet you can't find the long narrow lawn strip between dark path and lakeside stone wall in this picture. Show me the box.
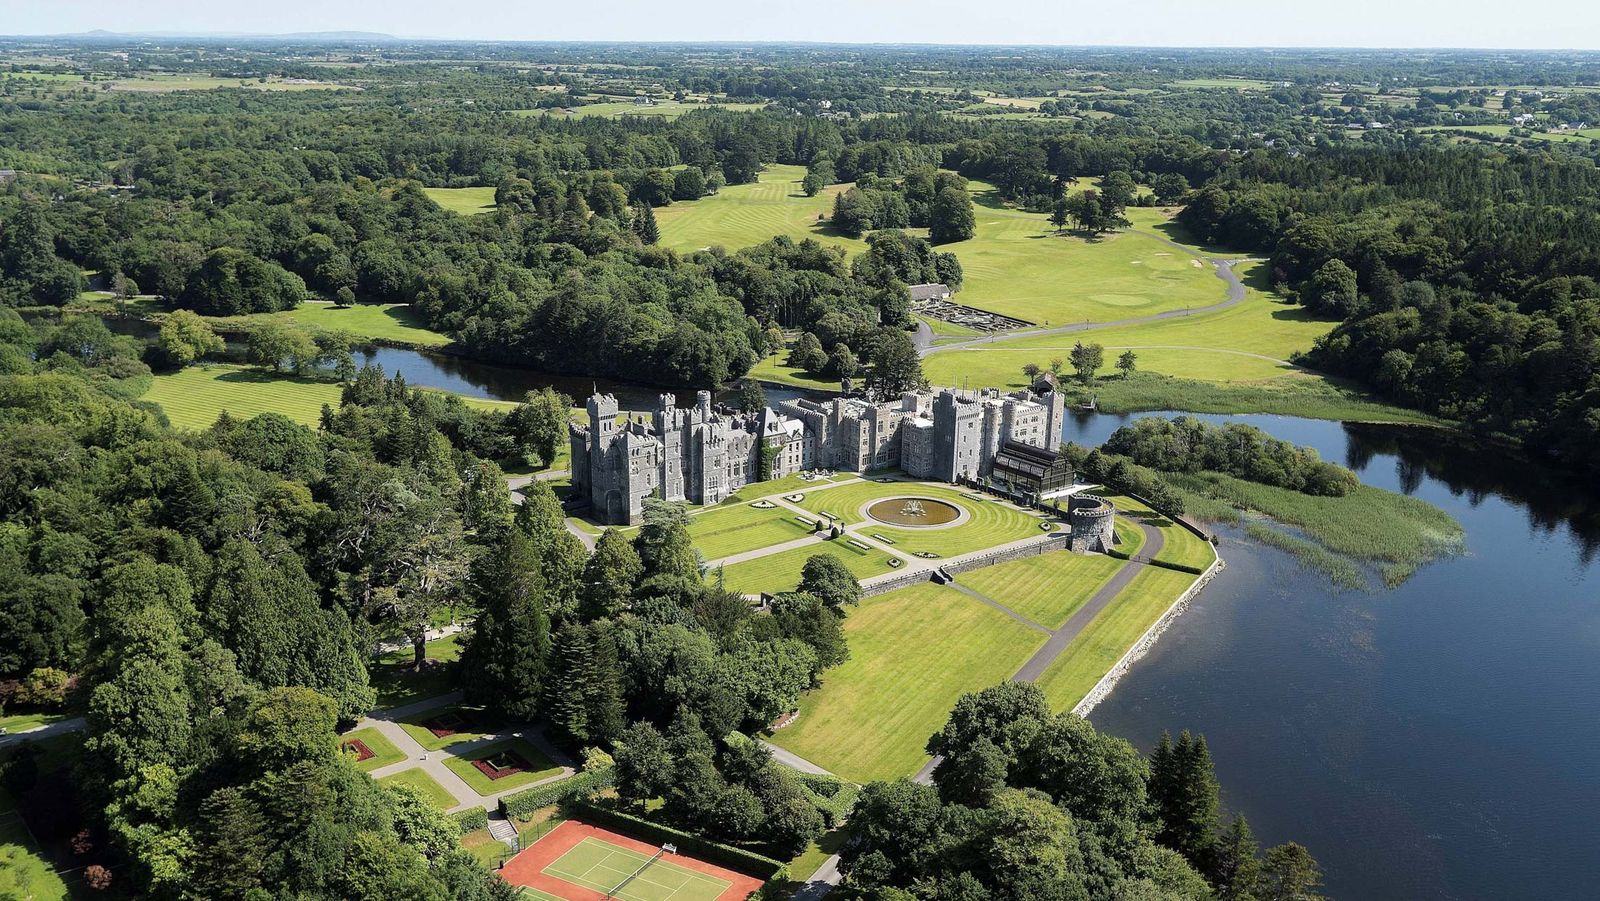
[1038,567,1198,711]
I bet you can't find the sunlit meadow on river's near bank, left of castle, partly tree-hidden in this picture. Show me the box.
[141,363,515,429]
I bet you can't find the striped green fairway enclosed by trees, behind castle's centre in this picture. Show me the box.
[656,165,867,253]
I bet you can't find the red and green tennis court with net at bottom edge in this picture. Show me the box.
[499,819,762,901]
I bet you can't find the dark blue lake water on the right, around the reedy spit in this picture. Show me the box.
[1066,414,1600,899]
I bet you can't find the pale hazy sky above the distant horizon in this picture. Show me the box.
[0,0,1600,50]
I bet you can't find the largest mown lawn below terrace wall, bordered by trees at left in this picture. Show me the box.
[771,583,1046,783]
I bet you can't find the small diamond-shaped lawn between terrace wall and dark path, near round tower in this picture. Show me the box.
[957,551,1128,629]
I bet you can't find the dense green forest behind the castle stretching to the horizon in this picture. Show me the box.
[0,45,1600,466]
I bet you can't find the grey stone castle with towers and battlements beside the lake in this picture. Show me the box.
[571,389,1064,525]
